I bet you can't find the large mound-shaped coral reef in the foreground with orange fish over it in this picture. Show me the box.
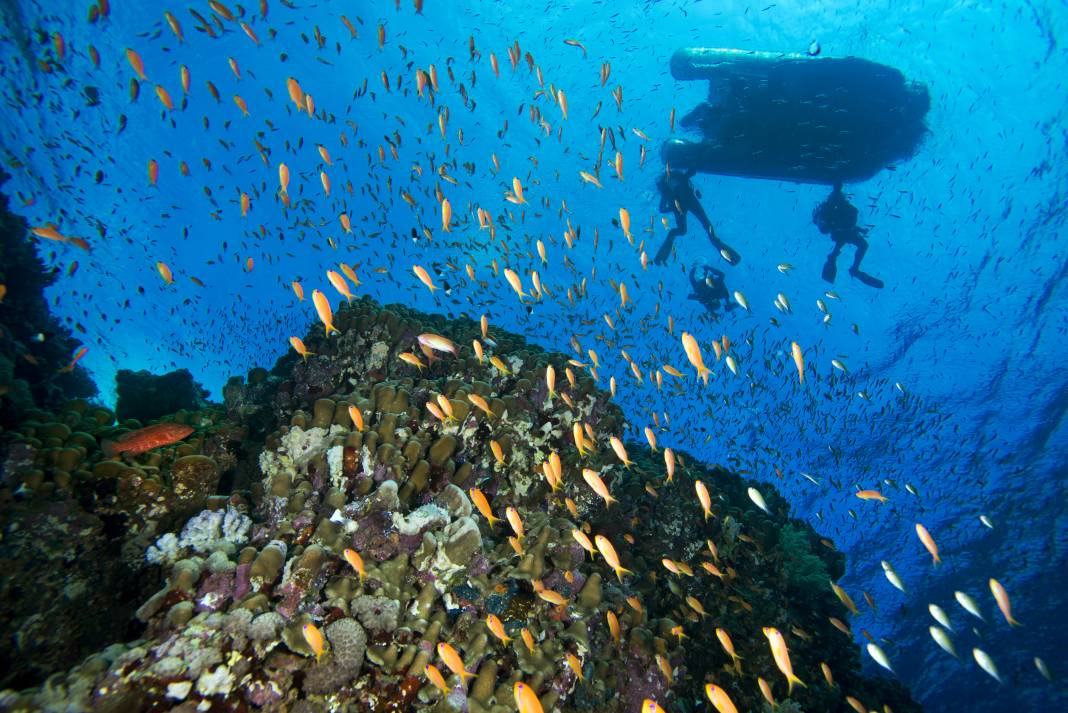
[0,300,918,713]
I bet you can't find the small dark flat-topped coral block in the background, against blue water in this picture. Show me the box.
[115,369,208,423]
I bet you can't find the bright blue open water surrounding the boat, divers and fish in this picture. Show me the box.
[0,0,1068,711]
